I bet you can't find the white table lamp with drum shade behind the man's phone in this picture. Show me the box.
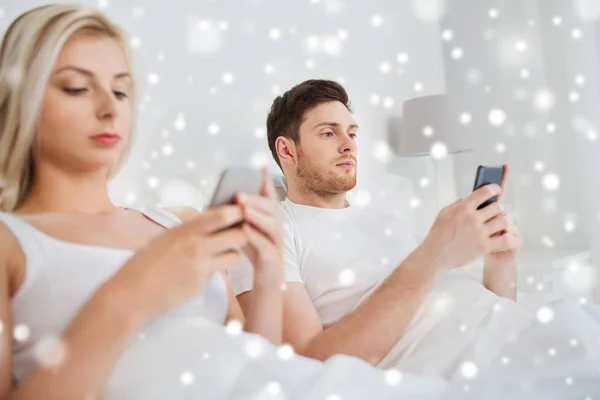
[397,95,473,209]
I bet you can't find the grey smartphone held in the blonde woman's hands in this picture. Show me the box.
[208,167,263,208]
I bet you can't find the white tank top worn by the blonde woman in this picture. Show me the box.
[0,209,228,381]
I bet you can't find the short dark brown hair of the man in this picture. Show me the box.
[267,79,352,168]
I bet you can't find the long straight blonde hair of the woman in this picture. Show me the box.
[0,4,135,212]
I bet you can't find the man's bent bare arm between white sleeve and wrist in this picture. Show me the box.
[282,244,440,365]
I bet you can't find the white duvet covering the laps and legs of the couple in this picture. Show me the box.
[103,274,600,400]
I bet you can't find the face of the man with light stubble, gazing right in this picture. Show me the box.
[296,101,358,194]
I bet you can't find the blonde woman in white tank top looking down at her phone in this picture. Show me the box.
[0,5,282,399]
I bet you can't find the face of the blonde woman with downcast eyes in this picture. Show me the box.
[36,32,133,173]
